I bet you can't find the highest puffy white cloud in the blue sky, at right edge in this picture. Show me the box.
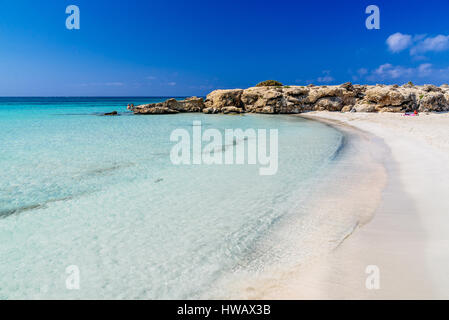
[386,32,449,59]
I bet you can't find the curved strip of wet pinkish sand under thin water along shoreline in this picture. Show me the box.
[218,114,389,299]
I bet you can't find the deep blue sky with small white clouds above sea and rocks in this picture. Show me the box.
[0,0,449,96]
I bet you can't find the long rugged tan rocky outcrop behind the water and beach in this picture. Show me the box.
[133,82,449,114]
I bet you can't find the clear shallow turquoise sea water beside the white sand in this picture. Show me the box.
[0,98,342,299]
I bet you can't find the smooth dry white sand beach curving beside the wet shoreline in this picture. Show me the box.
[231,112,449,299]
